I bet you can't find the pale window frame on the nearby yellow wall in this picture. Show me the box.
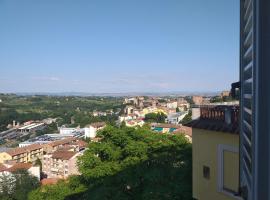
[217,144,242,200]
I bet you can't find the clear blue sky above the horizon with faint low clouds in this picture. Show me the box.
[0,0,239,92]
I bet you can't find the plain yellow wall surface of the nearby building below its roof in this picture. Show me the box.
[192,128,239,200]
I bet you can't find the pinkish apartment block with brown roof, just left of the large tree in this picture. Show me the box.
[42,150,83,179]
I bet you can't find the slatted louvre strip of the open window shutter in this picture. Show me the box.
[240,0,256,200]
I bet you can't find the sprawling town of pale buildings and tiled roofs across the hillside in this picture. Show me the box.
[0,91,237,188]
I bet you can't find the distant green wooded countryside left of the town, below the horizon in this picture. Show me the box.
[0,94,124,131]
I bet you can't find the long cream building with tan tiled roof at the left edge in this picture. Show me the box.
[0,144,43,163]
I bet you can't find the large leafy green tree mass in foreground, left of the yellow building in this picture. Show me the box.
[29,126,192,200]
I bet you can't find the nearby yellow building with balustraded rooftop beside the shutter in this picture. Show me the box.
[187,105,239,200]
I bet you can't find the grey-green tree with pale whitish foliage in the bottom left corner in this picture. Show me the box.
[0,170,39,200]
